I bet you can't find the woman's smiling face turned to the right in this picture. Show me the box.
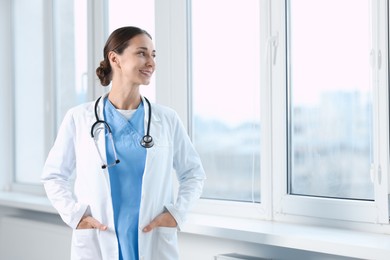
[110,34,156,85]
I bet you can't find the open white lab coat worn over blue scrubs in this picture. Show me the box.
[42,94,205,260]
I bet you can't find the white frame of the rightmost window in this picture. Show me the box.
[272,0,389,224]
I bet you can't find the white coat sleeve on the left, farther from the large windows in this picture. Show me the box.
[41,112,87,228]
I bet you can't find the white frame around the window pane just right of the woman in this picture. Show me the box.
[155,0,272,219]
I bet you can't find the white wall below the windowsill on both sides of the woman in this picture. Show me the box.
[0,207,360,260]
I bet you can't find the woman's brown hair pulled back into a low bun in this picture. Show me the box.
[96,26,152,86]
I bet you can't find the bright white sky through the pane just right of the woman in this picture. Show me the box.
[192,0,261,125]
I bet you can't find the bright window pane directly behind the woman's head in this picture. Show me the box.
[108,0,155,101]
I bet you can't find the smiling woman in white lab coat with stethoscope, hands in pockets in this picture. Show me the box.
[42,27,205,260]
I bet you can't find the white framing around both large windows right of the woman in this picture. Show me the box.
[155,0,389,224]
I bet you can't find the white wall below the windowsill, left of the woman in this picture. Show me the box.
[0,207,71,260]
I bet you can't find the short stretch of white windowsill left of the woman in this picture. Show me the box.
[0,191,57,214]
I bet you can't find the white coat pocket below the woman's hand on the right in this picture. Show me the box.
[156,227,179,260]
